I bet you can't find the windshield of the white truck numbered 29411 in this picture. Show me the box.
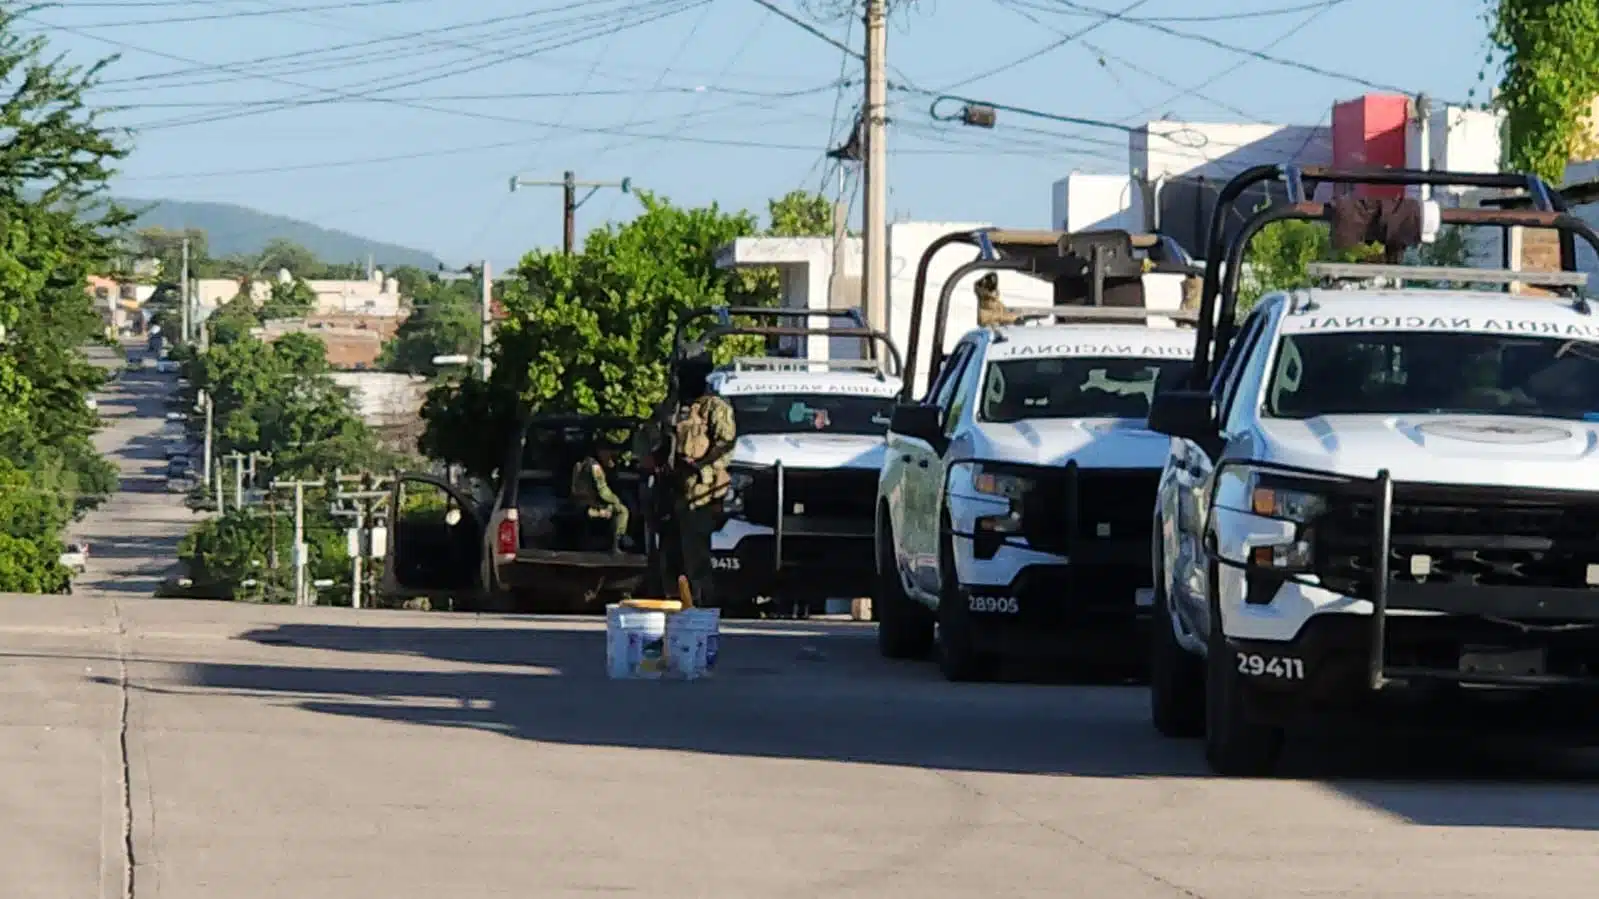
[1266,331,1599,421]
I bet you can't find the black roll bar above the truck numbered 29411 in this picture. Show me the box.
[1190,165,1579,390]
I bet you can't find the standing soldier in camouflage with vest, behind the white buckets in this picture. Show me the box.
[662,354,737,606]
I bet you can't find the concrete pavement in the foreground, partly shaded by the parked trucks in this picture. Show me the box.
[0,595,1599,899]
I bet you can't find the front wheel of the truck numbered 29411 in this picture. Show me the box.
[1204,579,1282,777]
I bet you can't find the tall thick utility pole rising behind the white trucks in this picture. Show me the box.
[860,0,889,347]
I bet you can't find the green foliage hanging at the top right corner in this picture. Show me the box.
[1485,0,1599,184]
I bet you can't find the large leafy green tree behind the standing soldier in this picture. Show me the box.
[421,192,764,477]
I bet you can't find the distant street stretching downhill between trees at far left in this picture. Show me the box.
[69,350,197,597]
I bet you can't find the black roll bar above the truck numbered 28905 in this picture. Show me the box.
[900,229,1201,402]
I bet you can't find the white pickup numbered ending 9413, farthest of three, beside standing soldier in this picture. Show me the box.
[708,358,900,617]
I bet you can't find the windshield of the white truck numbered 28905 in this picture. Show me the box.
[977,357,1190,422]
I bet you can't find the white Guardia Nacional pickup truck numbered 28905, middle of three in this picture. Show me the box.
[873,225,1193,680]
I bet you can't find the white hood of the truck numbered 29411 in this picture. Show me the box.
[1249,414,1599,489]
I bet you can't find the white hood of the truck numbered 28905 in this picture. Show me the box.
[972,418,1170,469]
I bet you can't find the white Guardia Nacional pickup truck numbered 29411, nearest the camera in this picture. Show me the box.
[1150,166,1599,774]
